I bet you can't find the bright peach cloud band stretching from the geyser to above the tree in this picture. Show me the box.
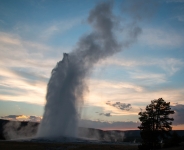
[84,79,184,116]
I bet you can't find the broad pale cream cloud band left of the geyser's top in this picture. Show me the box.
[0,32,69,76]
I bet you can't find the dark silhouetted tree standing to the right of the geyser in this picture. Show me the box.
[138,98,174,150]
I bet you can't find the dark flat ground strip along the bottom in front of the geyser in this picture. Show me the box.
[0,141,184,150]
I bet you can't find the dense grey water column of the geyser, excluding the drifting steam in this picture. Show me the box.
[38,53,77,137]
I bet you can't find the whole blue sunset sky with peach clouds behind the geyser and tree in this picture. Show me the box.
[0,0,184,130]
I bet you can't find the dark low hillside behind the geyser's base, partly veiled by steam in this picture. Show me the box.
[0,119,184,142]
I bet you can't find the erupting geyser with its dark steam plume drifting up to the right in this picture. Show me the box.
[37,3,140,138]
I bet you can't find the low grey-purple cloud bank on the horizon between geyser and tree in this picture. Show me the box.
[79,120,140,130]
